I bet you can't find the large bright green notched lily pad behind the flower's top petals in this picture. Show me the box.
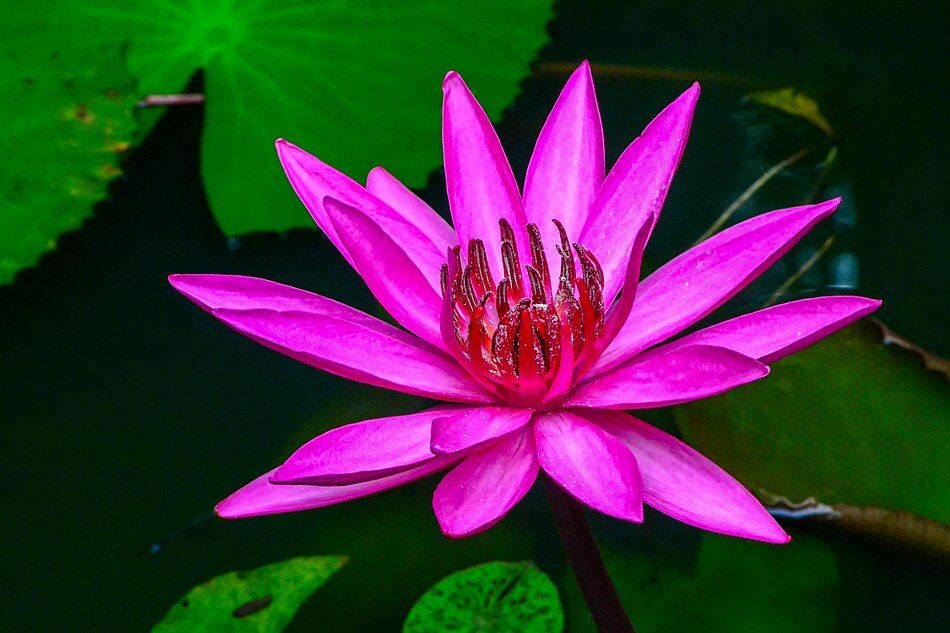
[11,0,551,235]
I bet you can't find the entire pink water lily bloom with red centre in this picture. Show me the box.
[170,63,880,543]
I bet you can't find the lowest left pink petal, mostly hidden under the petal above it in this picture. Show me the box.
[214,457,458,519]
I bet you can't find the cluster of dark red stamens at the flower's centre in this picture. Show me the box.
[442,220,604,406]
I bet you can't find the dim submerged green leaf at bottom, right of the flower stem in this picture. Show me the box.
[564,534,839,633]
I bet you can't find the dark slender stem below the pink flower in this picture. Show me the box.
[544,477,635,633]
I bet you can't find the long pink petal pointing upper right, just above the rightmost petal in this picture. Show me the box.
[591,198,840,373]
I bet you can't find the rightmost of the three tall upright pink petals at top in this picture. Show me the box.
[578,84,699,302]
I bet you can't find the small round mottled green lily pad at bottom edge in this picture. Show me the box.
[403,561,564,633]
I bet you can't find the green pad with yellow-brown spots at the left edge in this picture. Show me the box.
[0,42,136,283]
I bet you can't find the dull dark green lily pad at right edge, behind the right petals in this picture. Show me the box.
[676,320,950,523]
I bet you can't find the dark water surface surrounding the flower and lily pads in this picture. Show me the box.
[0,2,950,631]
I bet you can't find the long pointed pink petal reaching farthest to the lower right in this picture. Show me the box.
[582,411,790,543]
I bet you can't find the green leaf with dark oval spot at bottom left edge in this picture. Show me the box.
[152,556,346,633]
